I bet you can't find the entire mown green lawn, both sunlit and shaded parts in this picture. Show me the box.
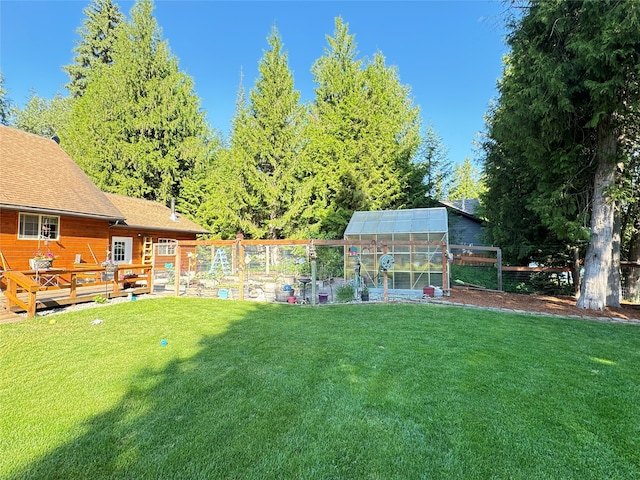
[0,298,640,480]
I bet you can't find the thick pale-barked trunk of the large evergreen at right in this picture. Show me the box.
[577,118,618,311]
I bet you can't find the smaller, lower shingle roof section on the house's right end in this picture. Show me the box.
[105,193,209,233]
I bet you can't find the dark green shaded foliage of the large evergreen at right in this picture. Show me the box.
[482,0,640,280]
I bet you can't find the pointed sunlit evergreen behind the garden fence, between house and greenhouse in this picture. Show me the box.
[202,27,306,239]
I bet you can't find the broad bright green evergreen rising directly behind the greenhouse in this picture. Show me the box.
[307,17,420,236]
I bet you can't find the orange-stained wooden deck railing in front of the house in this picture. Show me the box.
[4,264,153,318]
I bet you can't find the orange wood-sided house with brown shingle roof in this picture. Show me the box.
[0,126,208,270]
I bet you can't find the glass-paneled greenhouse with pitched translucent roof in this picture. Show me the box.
[344,207,449,290]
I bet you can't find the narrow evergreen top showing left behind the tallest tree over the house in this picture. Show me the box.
[62,0,124,98]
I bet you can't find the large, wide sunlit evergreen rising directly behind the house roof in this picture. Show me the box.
[62,0,214,203]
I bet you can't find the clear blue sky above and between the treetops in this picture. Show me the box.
[0,0,507,162]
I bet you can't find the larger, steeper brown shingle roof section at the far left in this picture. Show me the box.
[0,125,124,220]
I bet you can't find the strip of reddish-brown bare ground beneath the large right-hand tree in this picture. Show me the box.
[438,288,640,324]
